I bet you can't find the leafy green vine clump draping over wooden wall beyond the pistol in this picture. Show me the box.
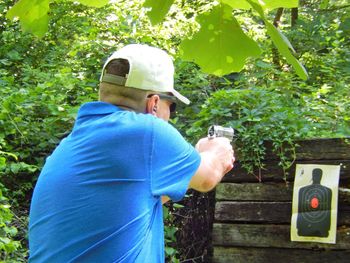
[188,87,308,173]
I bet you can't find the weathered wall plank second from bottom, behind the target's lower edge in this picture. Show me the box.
[213,223,350,250]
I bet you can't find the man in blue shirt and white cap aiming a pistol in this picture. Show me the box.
[29,44,234,263]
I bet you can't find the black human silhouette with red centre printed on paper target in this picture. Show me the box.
[297,168,332,237]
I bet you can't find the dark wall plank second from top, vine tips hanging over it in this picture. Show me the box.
[222,159,350,185]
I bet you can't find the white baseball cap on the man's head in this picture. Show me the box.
[100,44,190,104]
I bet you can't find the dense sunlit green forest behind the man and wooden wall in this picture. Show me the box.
[0,0,350,262]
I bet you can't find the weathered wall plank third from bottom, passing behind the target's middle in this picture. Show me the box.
[215,201,350,226]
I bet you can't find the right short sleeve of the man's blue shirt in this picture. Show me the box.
[150,120,201,201]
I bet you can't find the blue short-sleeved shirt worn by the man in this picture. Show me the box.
[29,102,200,263]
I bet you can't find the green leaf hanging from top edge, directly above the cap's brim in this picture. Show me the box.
[143,0,174,25]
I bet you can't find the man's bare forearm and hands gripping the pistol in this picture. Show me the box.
[189,137,235,192]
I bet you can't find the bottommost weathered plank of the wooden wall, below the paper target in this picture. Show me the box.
[213,247,350,263]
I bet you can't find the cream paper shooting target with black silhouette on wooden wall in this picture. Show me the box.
[290,164,340,244]
